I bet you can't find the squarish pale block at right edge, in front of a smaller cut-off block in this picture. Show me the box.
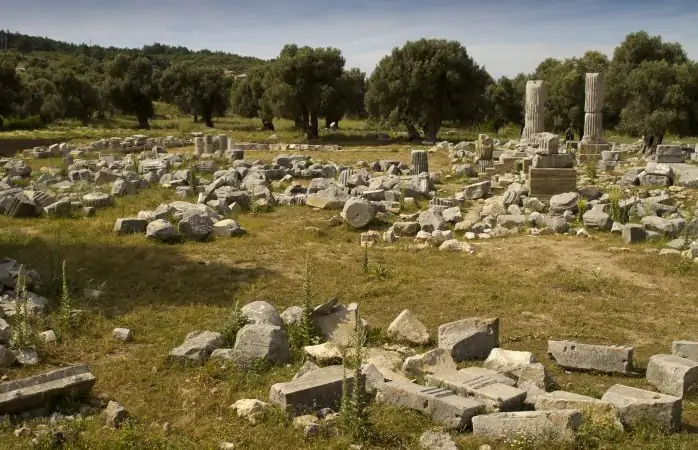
[647,355,698,397]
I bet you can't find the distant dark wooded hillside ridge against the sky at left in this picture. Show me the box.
[0,30,266,74]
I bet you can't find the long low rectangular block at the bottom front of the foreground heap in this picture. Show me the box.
[473,410,582,442]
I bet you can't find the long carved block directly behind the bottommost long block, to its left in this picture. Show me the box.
[376,380,485,430]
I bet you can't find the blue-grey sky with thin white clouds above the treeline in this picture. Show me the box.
[0,0,698,77]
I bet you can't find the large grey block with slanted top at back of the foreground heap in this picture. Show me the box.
[438,317,499,362]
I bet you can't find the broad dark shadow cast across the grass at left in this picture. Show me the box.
[0,235,278,316]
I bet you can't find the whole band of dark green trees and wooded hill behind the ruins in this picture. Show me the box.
[0,31,698,141]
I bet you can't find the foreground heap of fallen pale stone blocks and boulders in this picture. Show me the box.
[175,299,698,441]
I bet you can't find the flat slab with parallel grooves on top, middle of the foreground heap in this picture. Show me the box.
[427,370,526,411]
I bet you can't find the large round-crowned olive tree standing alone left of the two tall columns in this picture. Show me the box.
[366,39,491,141]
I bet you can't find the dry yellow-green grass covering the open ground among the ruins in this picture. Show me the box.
[0,121,698,449]
